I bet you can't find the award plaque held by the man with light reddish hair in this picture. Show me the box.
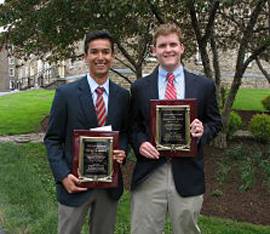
[150,99,197,157]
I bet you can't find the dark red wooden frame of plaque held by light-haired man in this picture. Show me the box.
[150,98,197,157]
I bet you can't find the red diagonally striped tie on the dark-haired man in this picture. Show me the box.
[96,87,106,126]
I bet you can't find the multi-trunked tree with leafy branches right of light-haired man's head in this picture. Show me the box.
[150,0,270,146]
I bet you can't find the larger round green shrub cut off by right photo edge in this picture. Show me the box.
[249,114,270,142]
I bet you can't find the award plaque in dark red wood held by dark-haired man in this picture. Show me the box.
[72,130,119,188]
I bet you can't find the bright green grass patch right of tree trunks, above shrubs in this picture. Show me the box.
[233,88,270,111]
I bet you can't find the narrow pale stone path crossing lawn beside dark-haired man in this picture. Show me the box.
[0,132,44,144]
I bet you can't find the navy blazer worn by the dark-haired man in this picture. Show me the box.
[44,76,129,206]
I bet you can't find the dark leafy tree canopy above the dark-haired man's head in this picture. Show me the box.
[0,0,153,81]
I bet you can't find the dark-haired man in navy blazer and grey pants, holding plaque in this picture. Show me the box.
[44,31,129,234]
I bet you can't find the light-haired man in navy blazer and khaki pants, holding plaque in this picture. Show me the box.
[131,24,222,234]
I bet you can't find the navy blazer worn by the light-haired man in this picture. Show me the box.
[130,68,222,197]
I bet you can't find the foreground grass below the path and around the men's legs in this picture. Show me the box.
[0,143,270,234]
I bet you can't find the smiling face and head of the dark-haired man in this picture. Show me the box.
[85,39,113,81]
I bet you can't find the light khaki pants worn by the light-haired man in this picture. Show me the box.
[131,161,203,234]
